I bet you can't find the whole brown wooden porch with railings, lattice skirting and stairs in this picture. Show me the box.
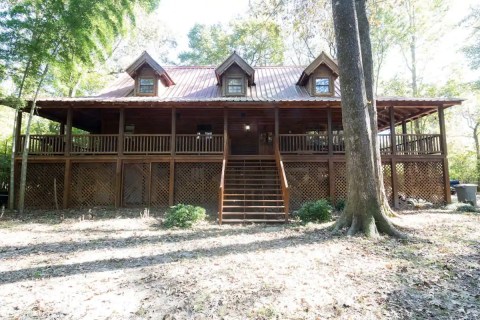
[13,107,450,223]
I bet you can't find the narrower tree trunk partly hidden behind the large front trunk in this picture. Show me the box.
[355,0,396,216]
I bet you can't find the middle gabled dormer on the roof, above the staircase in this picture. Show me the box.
[215,52,255,96]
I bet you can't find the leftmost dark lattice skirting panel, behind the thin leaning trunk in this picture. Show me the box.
[15,162,65,209]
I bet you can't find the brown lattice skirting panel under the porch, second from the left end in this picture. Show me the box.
[70,162,116,208]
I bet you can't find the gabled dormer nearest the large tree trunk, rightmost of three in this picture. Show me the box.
[297,52,339,96]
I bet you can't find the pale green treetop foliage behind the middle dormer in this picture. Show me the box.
[179,19,284,66]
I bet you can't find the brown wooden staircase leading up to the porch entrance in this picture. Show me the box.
[220,159,288,223]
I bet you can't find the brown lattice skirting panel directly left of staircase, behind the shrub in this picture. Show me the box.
[174,162,222,215]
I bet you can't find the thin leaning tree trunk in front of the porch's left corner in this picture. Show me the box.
[18,64,48,214]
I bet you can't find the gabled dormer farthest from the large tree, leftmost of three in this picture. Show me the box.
[125,51,175,96]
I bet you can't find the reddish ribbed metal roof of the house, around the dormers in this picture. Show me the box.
[33,66,462,106]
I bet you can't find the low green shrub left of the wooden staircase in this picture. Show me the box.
[164,204,206,228]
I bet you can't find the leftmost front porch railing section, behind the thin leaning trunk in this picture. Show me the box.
[18,134,65,155]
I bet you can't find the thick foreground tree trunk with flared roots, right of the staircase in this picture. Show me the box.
[332,0,402,237]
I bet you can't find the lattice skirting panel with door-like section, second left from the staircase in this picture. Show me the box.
[122,162,170,209]
